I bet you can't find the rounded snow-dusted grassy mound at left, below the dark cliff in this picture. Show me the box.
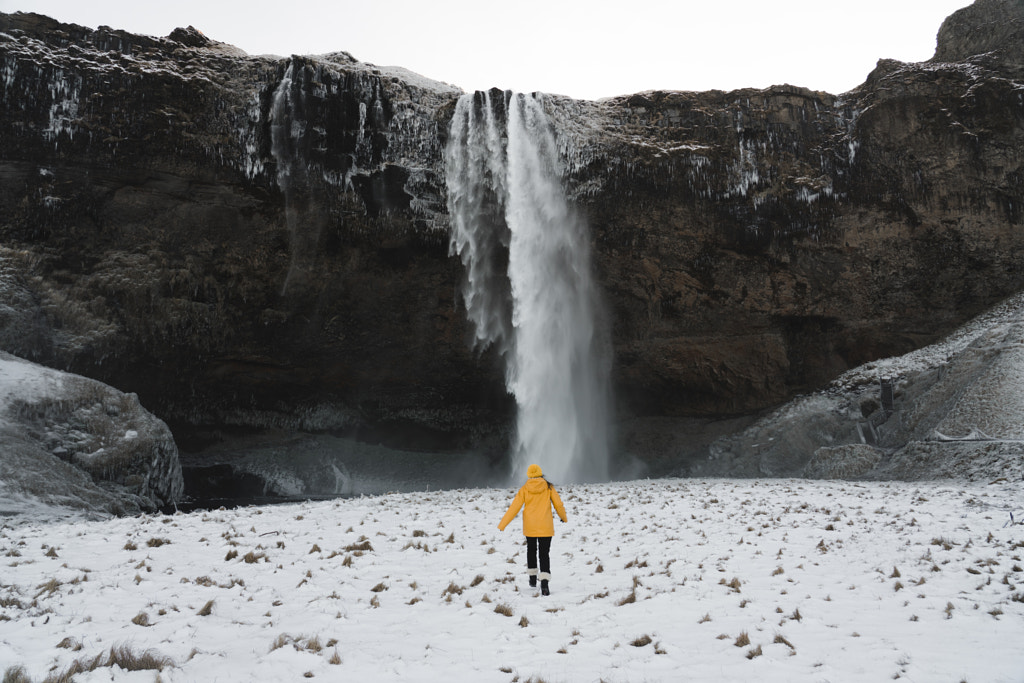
[0,351,183,514]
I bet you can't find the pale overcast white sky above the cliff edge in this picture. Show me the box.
[6,0,971,99]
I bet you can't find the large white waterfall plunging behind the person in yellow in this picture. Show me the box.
[445,91,610,482]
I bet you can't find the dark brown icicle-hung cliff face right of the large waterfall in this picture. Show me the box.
[553,0,1024,415]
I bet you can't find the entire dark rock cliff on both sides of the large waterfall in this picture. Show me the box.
[0,0,1024,458]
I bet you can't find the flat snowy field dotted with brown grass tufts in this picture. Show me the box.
[0,479,1024,683]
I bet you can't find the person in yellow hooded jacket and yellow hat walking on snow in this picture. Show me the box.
[498,465,568,595]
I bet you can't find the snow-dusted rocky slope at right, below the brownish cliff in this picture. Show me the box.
[691,295,1024,481]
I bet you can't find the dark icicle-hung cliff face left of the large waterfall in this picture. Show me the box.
[0,14,499,445]
